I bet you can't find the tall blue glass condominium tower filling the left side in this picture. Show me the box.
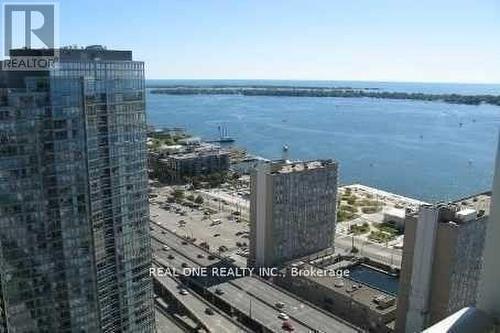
[0,46,155,332]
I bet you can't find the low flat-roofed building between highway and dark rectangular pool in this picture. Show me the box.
[275,256,396,332]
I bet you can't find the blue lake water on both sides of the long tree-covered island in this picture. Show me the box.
[147,81,500,201]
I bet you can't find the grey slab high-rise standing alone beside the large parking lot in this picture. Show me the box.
[248,160,337,267]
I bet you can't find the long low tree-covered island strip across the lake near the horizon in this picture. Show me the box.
[151,85,500,106]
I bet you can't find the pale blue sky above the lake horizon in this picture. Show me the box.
[60,0,500,83]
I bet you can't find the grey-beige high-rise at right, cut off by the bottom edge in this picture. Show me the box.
[396,193,490,332]
